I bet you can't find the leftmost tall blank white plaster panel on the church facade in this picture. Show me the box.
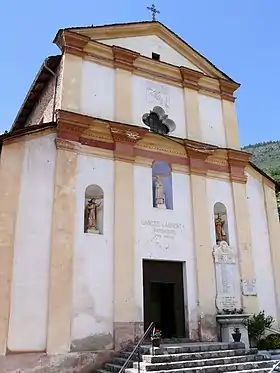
[8,134,56,351]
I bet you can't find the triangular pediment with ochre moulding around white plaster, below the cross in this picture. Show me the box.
[67,22,232,81]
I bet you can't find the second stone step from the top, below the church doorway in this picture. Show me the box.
[142,348,258,363]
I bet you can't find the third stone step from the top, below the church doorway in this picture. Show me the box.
[133,355,266,372]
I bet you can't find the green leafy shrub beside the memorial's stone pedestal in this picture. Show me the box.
[244,311,274,341]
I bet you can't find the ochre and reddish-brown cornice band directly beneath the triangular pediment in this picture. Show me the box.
[59,31,239,102]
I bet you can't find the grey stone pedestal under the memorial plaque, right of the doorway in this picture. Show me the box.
[216,314,251,348]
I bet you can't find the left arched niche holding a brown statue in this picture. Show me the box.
[84,184,104,234]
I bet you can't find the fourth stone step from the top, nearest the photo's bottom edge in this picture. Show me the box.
[125,360,276,373]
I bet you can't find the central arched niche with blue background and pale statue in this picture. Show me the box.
[152,161,173,210]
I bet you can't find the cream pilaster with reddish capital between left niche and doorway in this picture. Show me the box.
[110,125,146,350]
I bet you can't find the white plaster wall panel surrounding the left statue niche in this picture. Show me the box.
[71,155,114,349]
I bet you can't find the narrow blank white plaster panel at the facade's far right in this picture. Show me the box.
[247,175,277,320]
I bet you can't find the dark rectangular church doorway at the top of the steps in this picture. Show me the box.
[143,260,186,338]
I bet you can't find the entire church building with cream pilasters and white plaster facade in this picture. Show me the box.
[0,13,280,370]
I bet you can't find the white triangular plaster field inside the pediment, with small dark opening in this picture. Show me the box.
[99,35,201,71]
